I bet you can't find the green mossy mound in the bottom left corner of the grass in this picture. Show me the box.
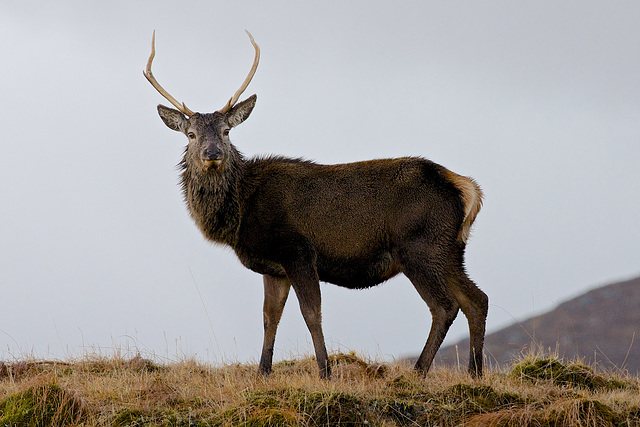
[0,384,85,427]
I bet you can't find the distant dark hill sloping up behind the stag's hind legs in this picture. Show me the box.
[435,277,640,375]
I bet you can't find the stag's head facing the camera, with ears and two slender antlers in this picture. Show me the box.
[143,31,260,172]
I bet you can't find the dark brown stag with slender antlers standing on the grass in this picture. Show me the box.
[144,32,488,378]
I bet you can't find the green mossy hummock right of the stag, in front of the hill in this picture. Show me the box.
[511,359,626,391]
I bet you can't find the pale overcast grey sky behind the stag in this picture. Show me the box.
[0,0,640,362]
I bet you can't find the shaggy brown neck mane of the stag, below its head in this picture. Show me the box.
[178,149,244,247]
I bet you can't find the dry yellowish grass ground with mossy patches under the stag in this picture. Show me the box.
[0,354,640,426]
